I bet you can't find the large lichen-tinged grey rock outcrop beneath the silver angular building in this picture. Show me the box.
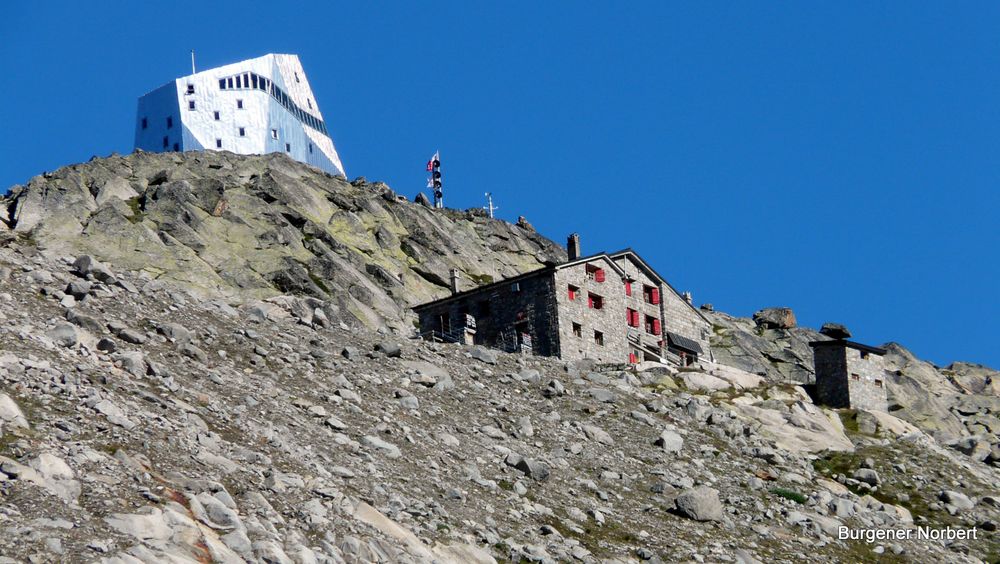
[3,151,565,332]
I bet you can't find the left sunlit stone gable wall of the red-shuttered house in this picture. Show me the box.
[555,258,630,362]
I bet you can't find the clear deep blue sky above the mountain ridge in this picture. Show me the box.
[0,1,1000,367]
